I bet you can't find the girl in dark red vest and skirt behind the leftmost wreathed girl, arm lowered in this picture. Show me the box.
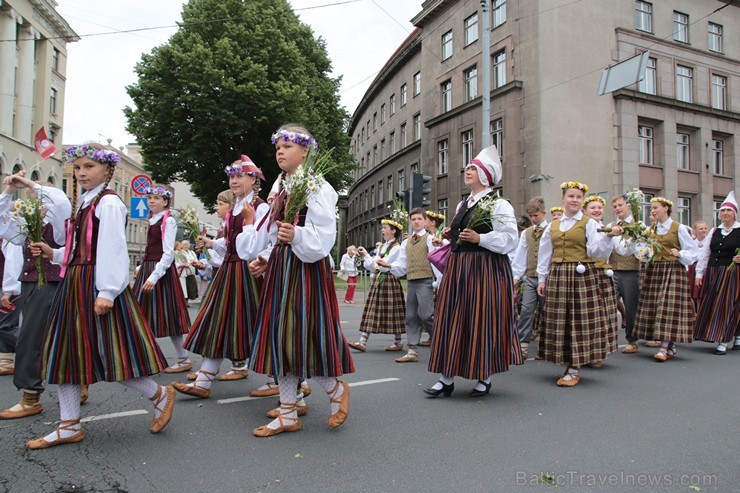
[133,186,193,373]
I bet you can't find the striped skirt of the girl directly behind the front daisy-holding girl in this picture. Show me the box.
[183,261,260,361]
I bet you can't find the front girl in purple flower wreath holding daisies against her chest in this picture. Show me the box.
[249,125,354,437]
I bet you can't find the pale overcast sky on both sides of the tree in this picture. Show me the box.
[57,0,422,147]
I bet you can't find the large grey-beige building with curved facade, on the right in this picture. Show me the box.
[346,0,740,245]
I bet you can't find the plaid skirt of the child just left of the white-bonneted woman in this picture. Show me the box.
[360,272,406,334]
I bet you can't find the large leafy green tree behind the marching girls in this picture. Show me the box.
[124,0,355,204]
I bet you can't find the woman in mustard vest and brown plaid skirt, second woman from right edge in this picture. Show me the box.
[635,197,698,362]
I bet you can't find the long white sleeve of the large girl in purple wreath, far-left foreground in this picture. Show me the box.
[94,195,129,301]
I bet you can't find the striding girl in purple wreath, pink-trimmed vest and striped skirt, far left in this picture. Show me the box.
[26,144,175,449]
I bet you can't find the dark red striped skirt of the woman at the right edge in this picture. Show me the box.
[694,266,740,342]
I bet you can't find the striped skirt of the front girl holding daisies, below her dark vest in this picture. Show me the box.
[249,244,355,378]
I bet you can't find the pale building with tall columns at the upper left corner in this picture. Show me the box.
[0,0,80,183]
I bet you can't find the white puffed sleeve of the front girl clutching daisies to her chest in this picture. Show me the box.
[292,183,338,263]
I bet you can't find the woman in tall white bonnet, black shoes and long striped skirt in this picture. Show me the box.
[424,146,523,397]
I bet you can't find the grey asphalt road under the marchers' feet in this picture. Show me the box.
[0,296,740,493]
